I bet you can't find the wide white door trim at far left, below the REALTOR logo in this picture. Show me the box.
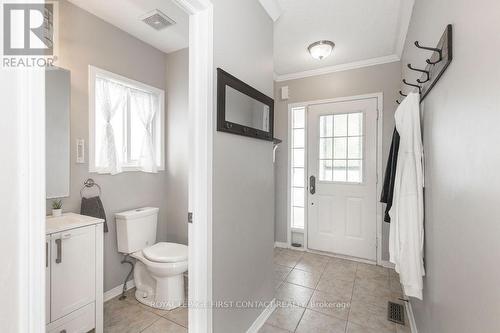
[0,68,45,333]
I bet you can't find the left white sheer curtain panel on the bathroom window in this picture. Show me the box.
[95,77,127,175]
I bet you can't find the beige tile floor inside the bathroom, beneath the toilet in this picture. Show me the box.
[104,288,188,333]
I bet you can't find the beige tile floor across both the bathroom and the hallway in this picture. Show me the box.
[104,248,410,333]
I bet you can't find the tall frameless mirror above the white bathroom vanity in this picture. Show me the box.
[45,67,71,199]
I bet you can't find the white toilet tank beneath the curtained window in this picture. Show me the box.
[115,207,159,254]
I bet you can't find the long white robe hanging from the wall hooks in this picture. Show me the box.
[389,93,425,299]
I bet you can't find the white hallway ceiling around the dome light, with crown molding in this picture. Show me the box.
[274,0,413,81]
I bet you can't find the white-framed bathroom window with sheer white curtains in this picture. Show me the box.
[89,66,165,174]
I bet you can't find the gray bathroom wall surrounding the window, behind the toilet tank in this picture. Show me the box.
[47,1,167,291]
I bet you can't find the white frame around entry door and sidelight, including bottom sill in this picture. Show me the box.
[287,92,384,265]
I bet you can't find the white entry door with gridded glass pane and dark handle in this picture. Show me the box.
[307,98,377,261]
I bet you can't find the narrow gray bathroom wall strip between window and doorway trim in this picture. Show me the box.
[165,49,189,244]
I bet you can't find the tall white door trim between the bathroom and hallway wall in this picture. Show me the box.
[174,0,214,333]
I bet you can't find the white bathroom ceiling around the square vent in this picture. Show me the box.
[69,0,189,53]
